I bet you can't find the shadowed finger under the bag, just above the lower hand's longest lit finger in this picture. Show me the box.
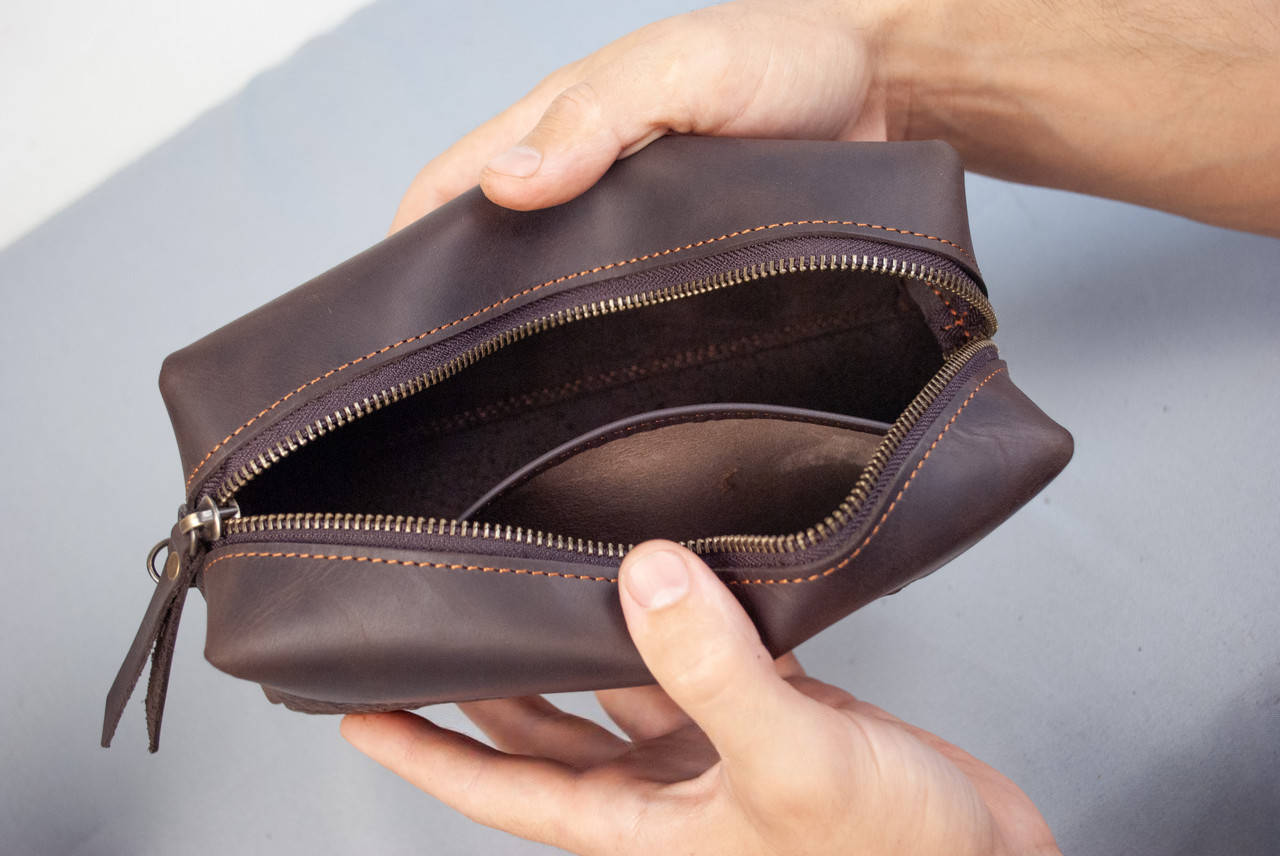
[458,696,627,769]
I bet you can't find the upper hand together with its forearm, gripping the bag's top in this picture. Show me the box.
[392,0,1280,235]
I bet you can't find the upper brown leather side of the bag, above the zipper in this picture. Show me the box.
[160,137,980,498]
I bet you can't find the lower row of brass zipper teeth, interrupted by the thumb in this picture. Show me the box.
[223,339,993,558]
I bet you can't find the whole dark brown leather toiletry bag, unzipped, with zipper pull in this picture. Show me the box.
[102,137,1071,749]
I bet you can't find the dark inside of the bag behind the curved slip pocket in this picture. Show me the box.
[238,270,942,522]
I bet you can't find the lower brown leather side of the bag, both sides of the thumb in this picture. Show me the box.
[204,361,1071,708]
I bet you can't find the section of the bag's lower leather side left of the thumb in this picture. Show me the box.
[204,544,649,708]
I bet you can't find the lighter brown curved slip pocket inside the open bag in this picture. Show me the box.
[461,407,890,544]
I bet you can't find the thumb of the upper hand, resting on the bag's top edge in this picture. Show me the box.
[480,77,669,211]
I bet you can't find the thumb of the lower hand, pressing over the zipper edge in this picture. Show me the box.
[618,541,820,781]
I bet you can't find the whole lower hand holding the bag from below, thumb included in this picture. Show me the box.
[342,541,1059,856]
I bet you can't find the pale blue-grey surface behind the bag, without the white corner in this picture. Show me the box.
[0,0,1280,855]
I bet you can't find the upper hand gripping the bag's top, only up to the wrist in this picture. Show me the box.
[392,0,892,232]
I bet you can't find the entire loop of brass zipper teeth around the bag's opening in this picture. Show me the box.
[215,255,996,558]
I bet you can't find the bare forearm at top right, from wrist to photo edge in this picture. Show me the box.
[875,0,1280,234]
